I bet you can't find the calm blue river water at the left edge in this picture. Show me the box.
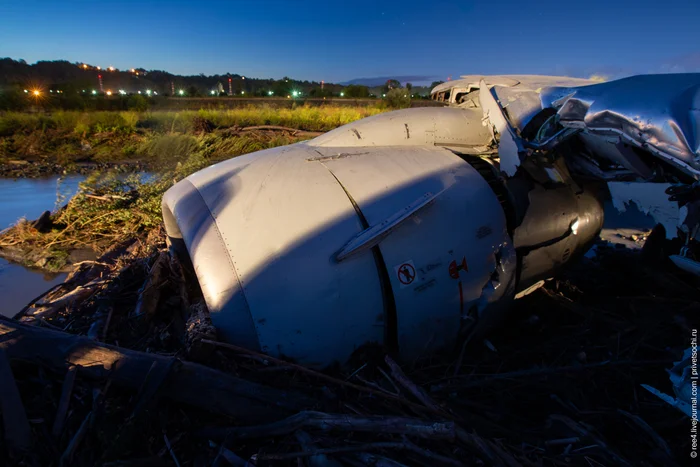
[0,175,85,316]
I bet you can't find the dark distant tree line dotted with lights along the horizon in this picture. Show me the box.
[0,58,429,110]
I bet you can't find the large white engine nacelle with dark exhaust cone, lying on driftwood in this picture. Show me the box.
[163,109,602,367]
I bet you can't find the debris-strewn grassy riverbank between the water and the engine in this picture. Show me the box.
[0,131,308,271]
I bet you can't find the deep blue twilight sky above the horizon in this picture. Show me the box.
[0,0,700,84]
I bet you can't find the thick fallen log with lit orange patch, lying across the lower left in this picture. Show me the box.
[0,318,317,422]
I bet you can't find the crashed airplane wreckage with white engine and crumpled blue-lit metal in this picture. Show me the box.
[163,74,700,367]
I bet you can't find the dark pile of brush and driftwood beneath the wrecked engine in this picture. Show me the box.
[0,230,700,466]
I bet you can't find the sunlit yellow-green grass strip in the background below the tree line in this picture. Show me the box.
[0,105,386,166]
